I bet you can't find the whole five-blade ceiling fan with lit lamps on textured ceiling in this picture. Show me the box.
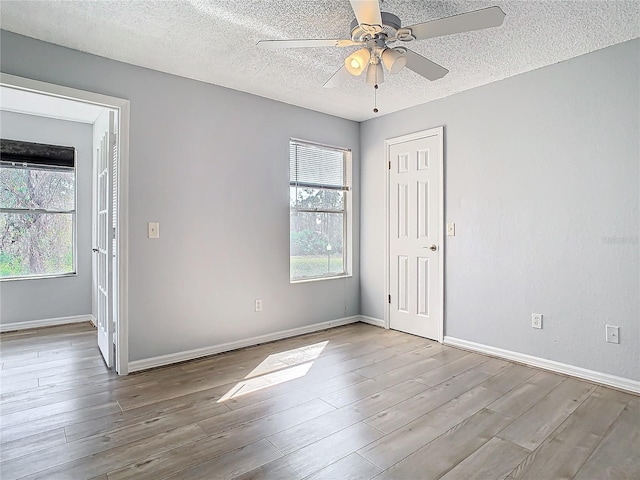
[257,0,505,91]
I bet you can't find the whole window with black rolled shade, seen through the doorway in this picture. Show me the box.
[0,139,76,279]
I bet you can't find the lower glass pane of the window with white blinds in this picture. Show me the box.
[290,212,344,279]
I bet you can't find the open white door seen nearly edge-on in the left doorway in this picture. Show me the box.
[93,110,117,367]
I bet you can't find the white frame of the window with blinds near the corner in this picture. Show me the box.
[289,137,353,284]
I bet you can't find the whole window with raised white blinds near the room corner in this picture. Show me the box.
[289,140,351,281]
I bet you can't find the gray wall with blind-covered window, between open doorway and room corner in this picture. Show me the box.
[0,31,360,360]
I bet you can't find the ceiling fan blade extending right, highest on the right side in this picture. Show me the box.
[406,7,505,40]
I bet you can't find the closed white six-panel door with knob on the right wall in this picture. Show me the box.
[387,128,443,341]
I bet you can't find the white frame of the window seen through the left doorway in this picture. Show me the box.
[0,146,78,282]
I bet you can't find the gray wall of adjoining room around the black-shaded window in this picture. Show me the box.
[0,112,93,324]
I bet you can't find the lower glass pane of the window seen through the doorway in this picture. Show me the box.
[0,213,74,277]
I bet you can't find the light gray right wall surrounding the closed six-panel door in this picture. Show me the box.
[360,40,640,379]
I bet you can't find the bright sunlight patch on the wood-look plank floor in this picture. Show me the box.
[218,341,329,403]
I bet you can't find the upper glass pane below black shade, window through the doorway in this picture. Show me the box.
[0,166,75,210]
